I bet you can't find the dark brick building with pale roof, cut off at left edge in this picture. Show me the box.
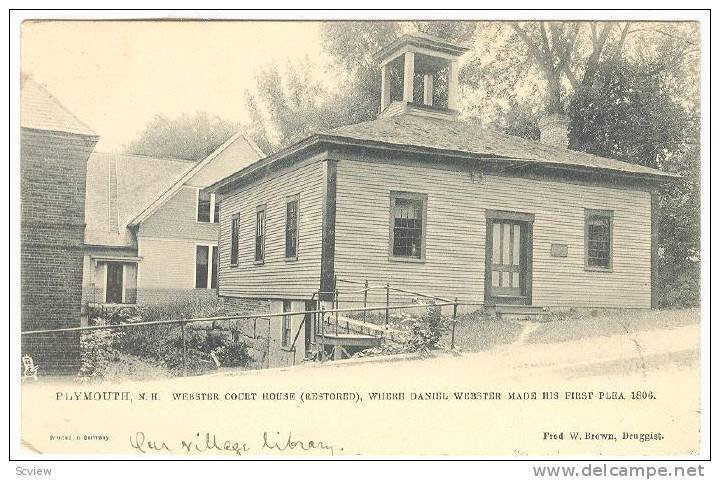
[20,76,98,375]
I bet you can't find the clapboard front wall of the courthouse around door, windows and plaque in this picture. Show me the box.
[335,158,650,308]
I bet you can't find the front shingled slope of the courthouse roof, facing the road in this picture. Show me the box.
[320,114,676,177]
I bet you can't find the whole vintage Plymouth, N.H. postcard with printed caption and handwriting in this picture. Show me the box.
[10,12,710,461]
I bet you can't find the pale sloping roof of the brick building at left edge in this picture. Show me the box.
[20,75,97,137]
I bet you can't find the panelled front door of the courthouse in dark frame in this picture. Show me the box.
[485,218,532,305]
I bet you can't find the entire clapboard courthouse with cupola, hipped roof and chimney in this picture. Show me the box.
[209,35,674,360]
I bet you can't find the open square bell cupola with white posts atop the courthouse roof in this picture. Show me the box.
[375,33,468,118]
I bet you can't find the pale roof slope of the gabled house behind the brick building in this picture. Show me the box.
[85,152,196,247]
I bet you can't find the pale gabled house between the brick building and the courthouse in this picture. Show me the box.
[83,133,263,305]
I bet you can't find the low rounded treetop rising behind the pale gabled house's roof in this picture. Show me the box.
[124,112,238,161]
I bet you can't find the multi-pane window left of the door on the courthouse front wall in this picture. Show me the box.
[390,192,427,261]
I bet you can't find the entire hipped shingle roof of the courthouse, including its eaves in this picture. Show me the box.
[209,113,680,195]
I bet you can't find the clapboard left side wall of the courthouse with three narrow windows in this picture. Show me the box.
[220,157,325,299]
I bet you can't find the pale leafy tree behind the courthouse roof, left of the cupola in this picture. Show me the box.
[246,22,476,151]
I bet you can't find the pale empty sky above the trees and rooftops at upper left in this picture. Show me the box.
[21,21,327,151]
